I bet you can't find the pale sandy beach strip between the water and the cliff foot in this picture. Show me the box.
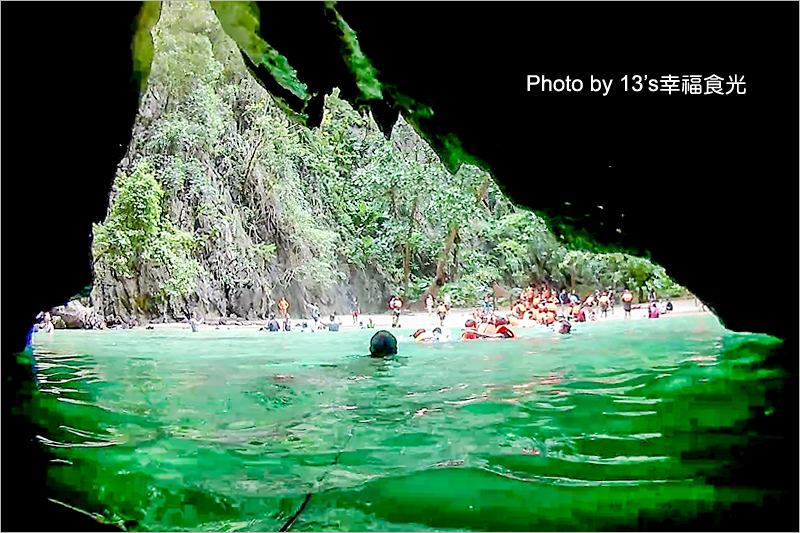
[147,298,710,331]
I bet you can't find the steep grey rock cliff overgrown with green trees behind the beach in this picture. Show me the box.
[92,2,681,319]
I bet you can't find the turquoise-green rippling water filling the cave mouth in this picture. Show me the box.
[29,315,782,531]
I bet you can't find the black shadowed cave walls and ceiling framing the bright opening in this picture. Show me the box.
[0,2,799,531]
